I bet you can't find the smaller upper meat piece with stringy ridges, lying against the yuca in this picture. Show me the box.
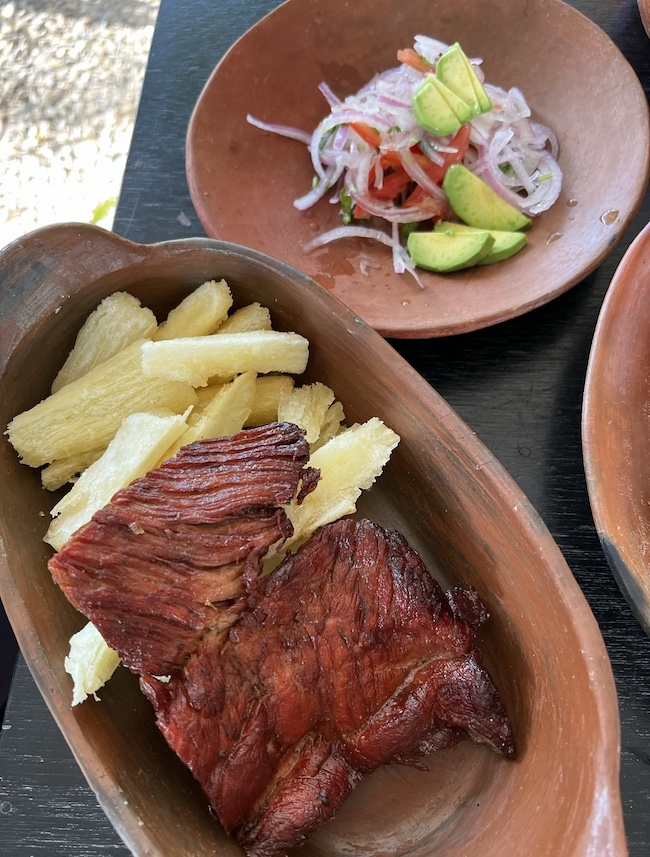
[49,424,317,675]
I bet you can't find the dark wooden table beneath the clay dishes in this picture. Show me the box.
[0,0,650,857]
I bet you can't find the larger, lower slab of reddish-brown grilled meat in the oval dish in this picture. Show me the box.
[141,520,514,857]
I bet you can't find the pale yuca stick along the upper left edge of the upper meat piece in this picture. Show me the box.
[43,412,187,550]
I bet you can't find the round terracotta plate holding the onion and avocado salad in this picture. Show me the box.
[186,0,649,338]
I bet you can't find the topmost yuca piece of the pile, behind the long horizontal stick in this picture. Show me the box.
[153,280,232,340]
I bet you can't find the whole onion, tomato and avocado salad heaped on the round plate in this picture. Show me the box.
[248,36,562,283]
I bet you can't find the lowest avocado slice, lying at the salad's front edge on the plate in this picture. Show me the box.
[407,231,494,273]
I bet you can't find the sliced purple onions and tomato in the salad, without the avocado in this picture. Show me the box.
[247,36,562,285]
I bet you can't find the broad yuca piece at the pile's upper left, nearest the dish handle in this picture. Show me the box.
[52,292,158,393]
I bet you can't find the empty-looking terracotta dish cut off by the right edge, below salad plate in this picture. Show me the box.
[582,225,650,634]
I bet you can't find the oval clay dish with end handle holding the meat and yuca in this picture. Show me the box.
[0,224,627,857]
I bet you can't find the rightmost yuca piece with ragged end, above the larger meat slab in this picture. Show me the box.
[284,417,399,550]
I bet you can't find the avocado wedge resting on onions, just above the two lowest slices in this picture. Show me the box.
[442,164,532,232]
